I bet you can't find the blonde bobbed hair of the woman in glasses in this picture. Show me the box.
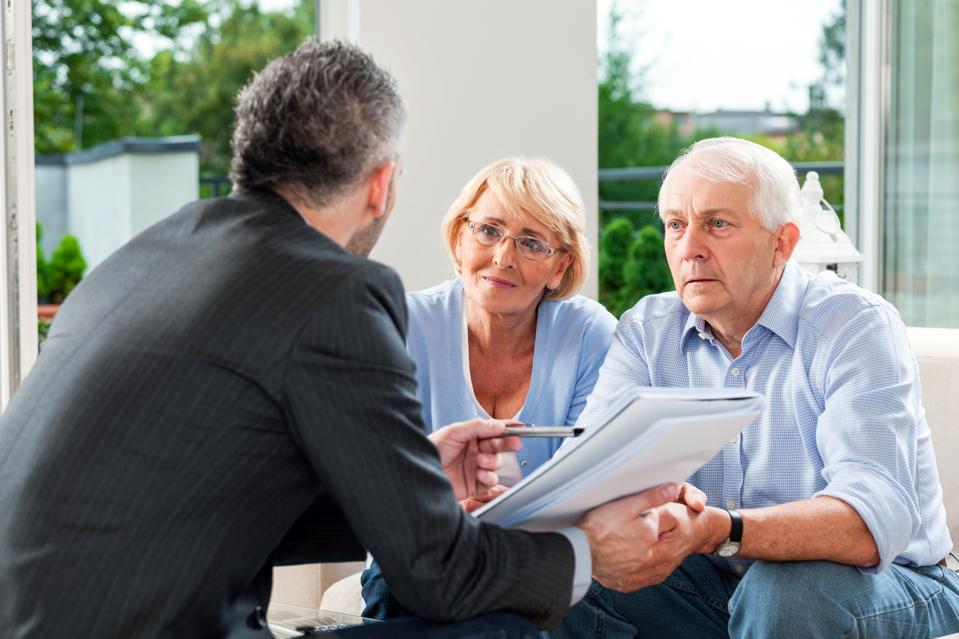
[443,157,589,300]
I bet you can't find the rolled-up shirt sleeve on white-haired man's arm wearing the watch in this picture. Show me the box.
[813,306,925,571]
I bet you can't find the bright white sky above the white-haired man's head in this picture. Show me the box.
[597,0,840,113]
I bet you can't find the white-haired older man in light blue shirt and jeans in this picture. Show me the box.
[560,138,959,637]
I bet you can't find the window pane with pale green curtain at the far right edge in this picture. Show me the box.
[879,0,959,327]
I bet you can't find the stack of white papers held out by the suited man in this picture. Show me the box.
[473,388,765,532]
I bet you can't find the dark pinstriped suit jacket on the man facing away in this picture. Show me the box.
[0,191,573,639]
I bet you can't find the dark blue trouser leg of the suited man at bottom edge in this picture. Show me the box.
[326,612,538,639]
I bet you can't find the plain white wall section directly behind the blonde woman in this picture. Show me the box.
[330,0,598,296]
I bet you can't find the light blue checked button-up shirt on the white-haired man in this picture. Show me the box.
[580,261,952,573]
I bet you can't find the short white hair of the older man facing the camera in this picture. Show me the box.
[657,137,802,231]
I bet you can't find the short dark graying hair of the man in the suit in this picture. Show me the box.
[230,38,406,206]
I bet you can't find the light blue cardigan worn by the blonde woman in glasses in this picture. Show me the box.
[406,278,616,476]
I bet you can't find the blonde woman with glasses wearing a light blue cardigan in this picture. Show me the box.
[363,158,616,618]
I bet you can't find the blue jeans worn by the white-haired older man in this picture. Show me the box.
[543,555,959,638]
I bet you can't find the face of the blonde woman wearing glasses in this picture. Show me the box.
[456,190,572,315]
